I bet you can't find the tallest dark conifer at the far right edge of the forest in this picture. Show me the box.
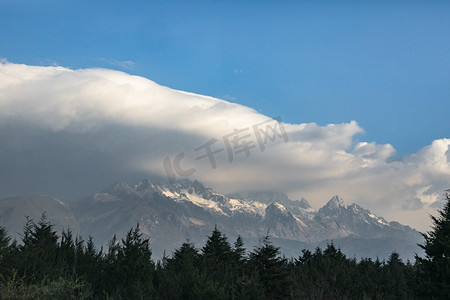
[416,190,450,299]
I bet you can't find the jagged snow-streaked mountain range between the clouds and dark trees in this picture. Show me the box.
[0,180,422,259]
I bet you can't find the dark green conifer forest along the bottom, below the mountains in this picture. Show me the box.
[0,192,450,299]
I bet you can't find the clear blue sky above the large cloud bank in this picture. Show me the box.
[0,1,450,156]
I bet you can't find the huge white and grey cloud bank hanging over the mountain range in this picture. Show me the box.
[0,60,450,229]
